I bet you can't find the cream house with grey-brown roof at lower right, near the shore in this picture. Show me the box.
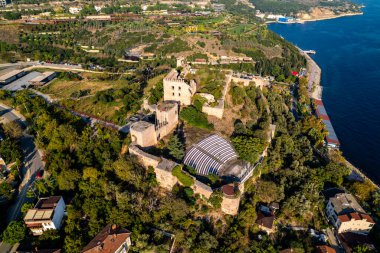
[326,193,375,234]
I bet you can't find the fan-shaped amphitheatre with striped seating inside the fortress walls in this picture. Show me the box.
[184,134,253,182]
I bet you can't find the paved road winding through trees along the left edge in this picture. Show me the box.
[0,105,44,223]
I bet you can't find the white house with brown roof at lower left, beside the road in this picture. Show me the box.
[24,196,66,235]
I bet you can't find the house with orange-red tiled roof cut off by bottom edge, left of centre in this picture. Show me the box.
[81,225,131,253]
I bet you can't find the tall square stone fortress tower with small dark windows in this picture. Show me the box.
[164,69,197,105]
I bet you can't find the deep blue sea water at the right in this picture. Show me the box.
[269,0,380,183]
